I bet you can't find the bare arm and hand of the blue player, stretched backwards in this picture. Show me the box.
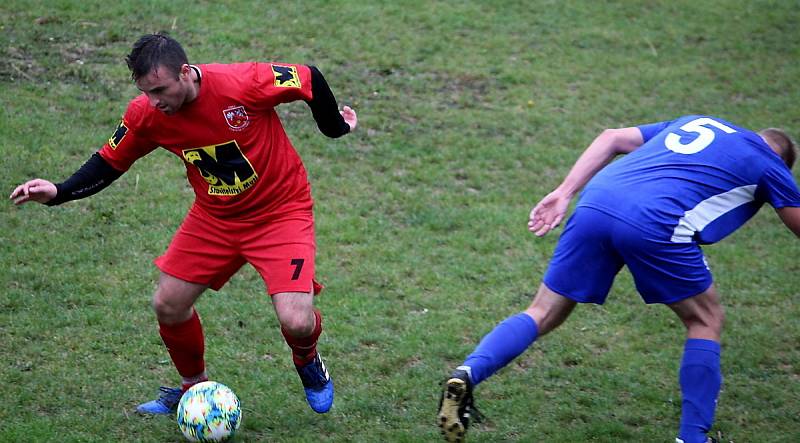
[528,127,644,236]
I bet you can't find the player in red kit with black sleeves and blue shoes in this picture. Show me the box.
[10,34,357,414]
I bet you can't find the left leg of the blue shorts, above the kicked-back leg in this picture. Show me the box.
[544,207,623,304]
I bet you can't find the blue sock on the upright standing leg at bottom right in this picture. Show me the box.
[679,338,722,443]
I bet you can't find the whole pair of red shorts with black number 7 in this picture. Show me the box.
[154,207,322,295]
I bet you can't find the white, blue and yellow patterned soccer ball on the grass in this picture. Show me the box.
[178,381,242,442]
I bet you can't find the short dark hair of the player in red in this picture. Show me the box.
[125,32,189,81]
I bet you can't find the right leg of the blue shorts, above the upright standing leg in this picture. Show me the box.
[614,224,713,304]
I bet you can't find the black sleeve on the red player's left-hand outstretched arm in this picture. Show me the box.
[47,152,123,206]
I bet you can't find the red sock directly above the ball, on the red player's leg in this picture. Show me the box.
[158,309,206,386]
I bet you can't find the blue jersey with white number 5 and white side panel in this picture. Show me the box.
[578,115,800,244]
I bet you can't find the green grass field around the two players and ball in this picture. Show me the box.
[0,0,800,443]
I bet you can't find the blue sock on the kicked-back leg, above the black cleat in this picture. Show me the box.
[459,312,539,385]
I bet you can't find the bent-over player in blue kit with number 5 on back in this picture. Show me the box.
[438,115,800,443]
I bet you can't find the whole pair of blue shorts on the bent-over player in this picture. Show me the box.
[544,207,713,304]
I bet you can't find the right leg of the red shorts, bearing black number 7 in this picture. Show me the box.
[242,212,320,295]
